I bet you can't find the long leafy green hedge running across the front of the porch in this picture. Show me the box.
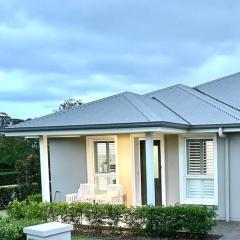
[8,201,216,238]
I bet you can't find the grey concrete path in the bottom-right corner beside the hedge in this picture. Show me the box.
[212,221,240,240]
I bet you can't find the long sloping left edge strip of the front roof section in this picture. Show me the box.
[9,92,133,128]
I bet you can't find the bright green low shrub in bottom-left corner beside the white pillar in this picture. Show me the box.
[0,218,43,240]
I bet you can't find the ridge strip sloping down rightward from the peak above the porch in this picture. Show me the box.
[124,92,158,121]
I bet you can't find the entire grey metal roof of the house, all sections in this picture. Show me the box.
[5,73,240,131]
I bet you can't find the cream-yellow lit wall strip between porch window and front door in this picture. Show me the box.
[117,134,133,206]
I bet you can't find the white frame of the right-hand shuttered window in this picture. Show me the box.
[179,134,218,205]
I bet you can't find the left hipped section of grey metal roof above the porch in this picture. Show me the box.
[9,92,186,129]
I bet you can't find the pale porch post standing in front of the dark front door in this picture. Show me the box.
[145,132,155,205]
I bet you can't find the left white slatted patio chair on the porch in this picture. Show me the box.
[65,183,95,203]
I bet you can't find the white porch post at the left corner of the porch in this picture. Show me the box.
[39,136,50,202]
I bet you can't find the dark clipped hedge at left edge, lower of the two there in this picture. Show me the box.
[0,185,18,209]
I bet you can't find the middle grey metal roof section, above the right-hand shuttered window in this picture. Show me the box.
[145,84,240,125]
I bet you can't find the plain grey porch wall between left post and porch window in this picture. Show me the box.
[49,137,87,201]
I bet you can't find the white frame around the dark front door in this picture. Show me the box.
[132,133,167,206]
